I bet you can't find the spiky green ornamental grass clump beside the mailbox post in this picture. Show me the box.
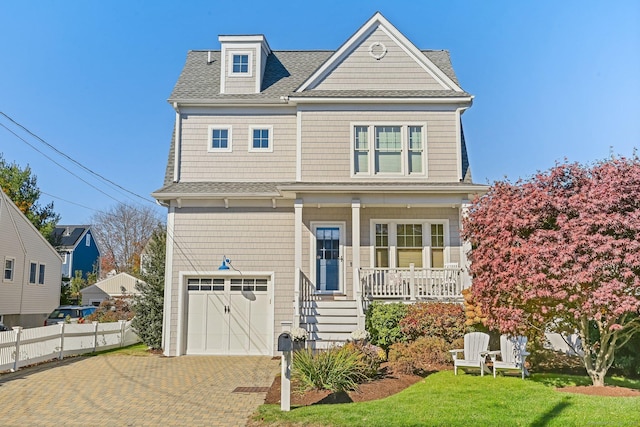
[292,346,369,393]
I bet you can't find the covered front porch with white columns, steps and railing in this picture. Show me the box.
[280,183,484,341]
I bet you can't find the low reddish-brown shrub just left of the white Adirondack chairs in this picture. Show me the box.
[389,337,458,375]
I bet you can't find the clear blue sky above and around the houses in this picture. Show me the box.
[0,0,640,224]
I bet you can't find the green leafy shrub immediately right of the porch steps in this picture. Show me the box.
[365,301,407,354]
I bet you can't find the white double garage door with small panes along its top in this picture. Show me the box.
[187,277,271,355]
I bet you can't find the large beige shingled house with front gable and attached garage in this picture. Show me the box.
[153,13,487,356]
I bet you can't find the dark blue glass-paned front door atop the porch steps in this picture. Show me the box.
[316,226,342,292]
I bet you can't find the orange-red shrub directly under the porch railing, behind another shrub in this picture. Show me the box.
[399,302,466,343]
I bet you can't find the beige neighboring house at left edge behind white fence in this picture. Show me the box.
[0,190,62,328]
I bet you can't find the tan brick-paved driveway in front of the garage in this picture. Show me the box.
[0,355,279,426]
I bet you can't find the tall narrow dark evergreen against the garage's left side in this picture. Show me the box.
[132,226,167,349]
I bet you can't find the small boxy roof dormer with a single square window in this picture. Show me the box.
[218,34,271,94]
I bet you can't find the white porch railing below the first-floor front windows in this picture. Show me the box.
[359,264,463,301]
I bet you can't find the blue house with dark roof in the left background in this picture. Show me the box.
[54,225,100,279]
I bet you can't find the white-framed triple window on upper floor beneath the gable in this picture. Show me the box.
[352,123,427,176]
